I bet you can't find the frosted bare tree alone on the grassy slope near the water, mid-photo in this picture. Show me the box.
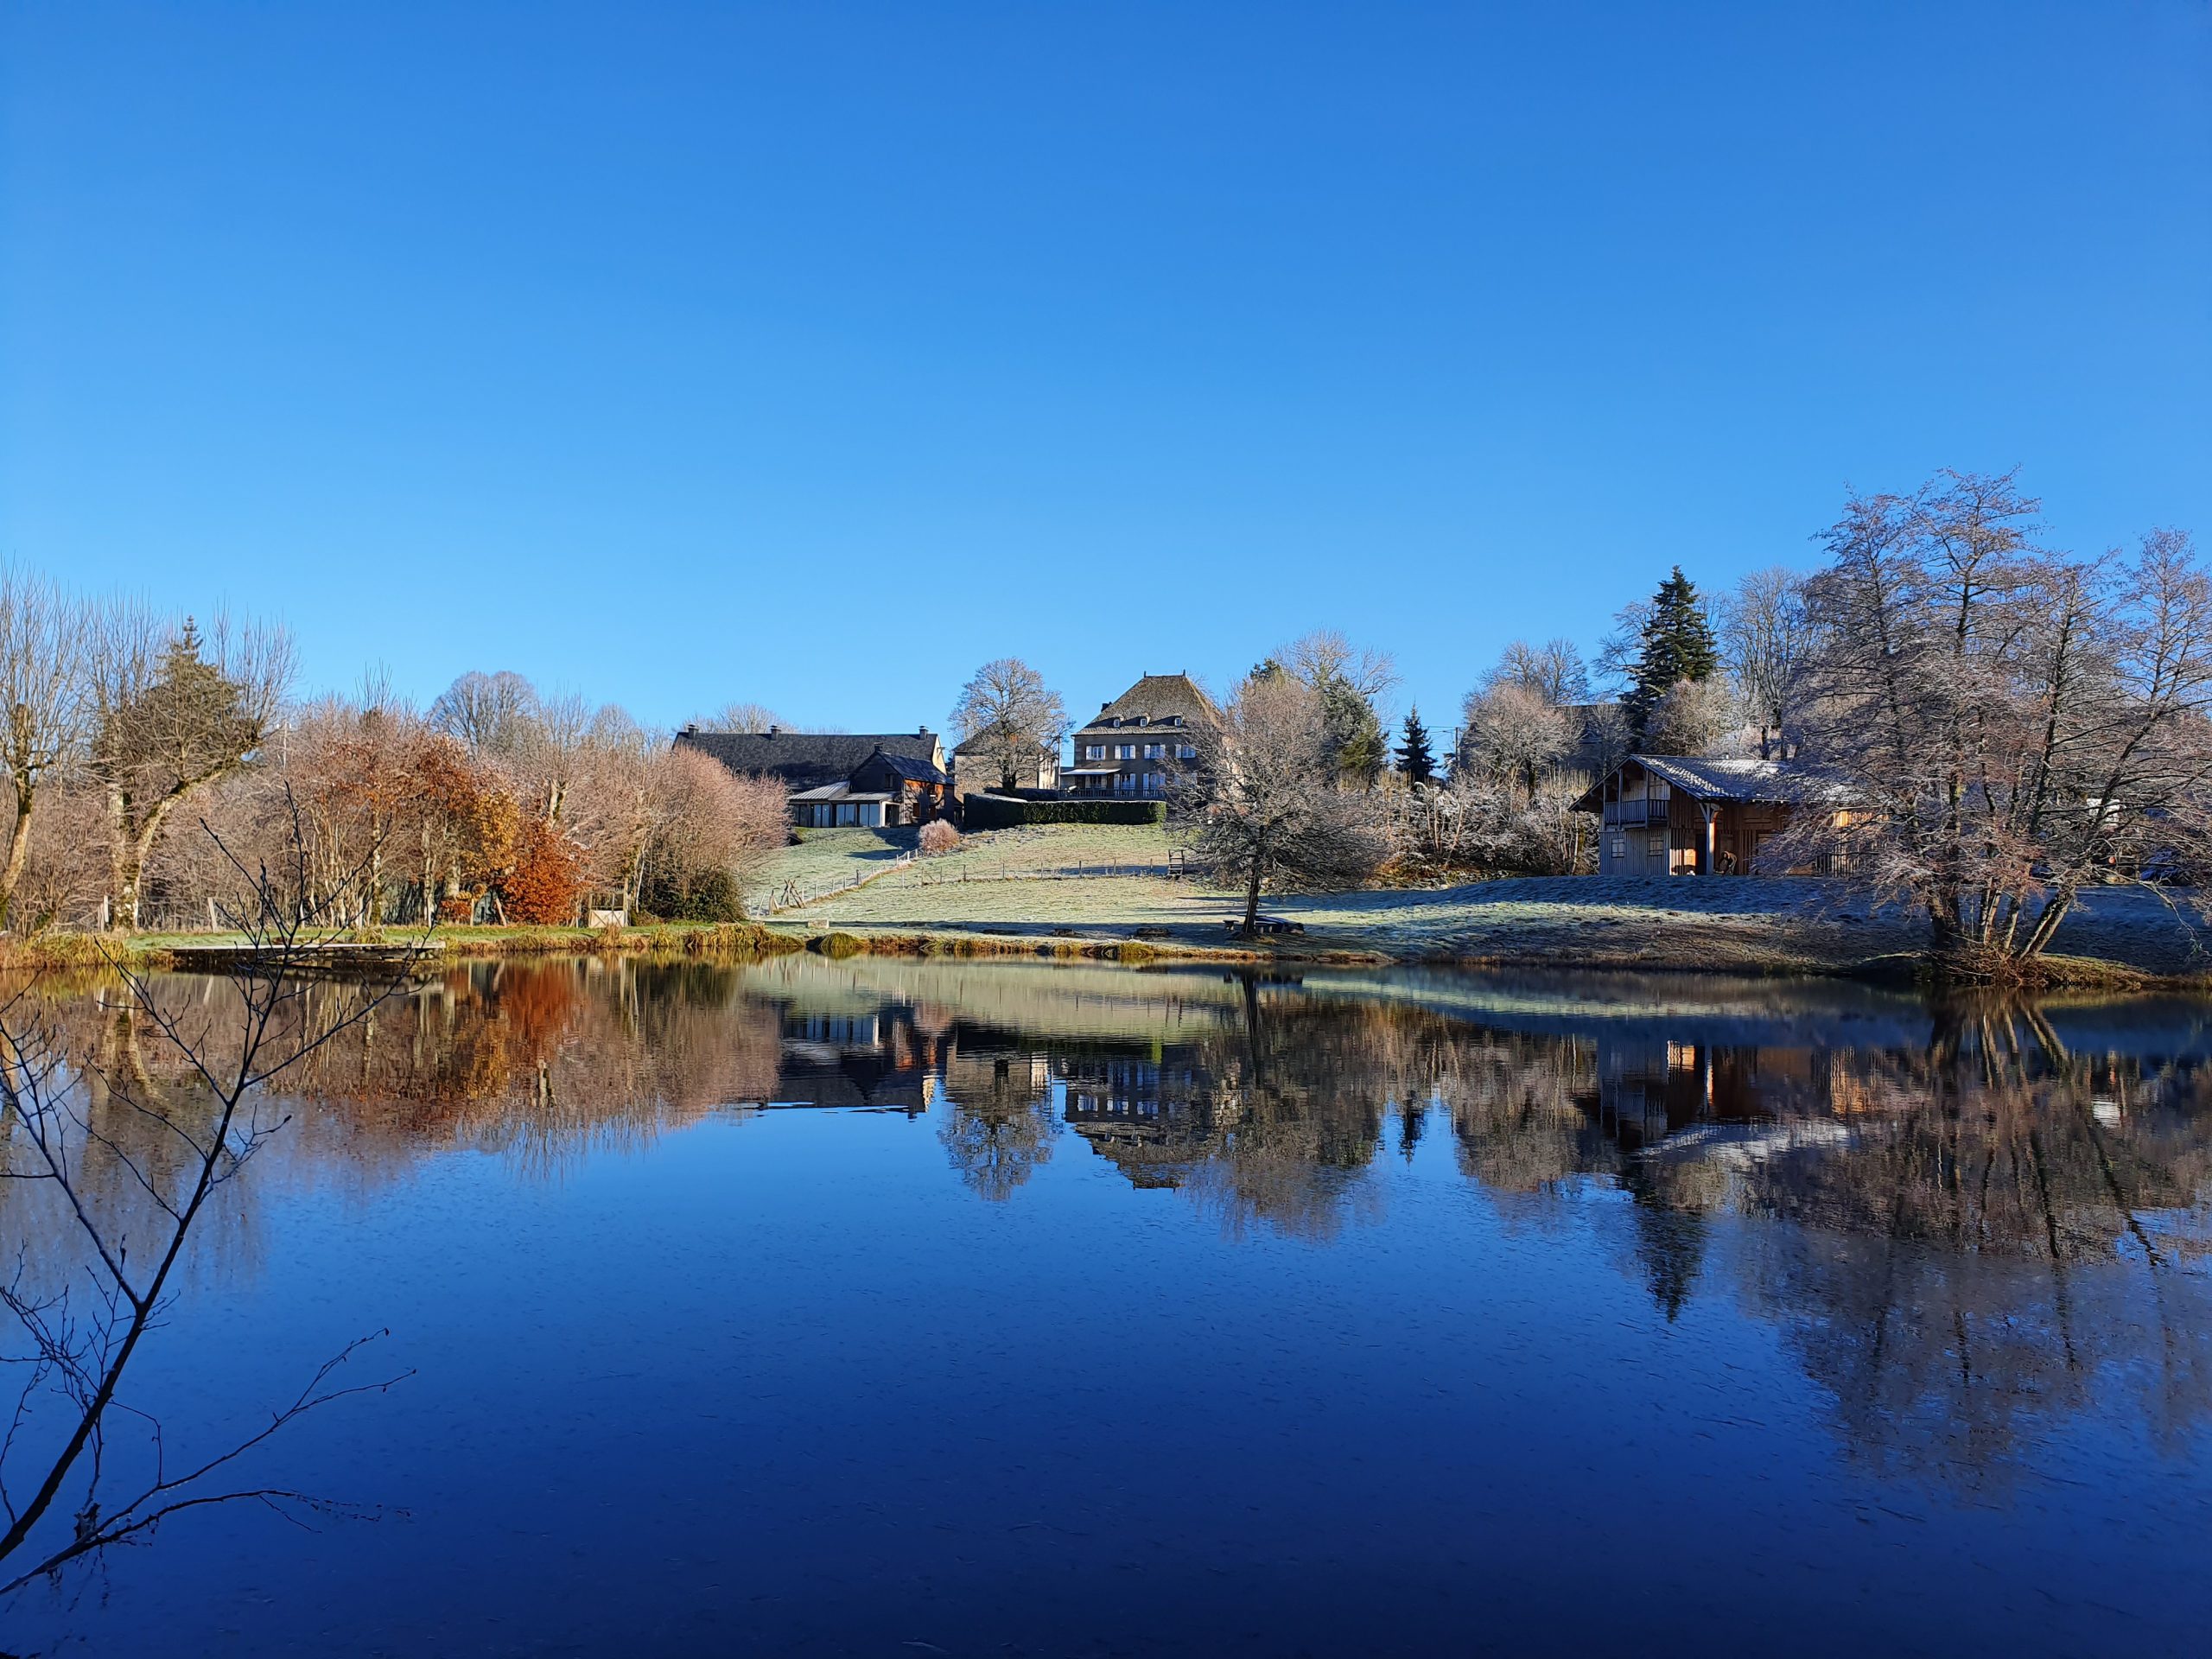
[1179,672,1389,933]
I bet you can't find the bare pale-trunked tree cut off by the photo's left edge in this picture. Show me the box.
[0,566,86,927]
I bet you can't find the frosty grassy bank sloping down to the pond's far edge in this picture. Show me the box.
[0,825,2212,984]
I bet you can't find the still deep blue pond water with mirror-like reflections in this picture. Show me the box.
[0,957,2212,1656]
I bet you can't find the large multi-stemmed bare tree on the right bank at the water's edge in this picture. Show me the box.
[1808,471,2212,978]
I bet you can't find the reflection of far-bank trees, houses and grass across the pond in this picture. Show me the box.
[21,957,2212,1478]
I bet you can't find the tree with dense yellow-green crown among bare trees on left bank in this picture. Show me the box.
[86,604,292,927]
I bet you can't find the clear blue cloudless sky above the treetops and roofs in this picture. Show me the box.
[0,0,2212,730]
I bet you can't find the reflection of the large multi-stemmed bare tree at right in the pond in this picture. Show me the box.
[1741,1008,2212,1473]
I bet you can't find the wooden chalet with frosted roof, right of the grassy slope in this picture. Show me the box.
[1575,754,1847,876]
